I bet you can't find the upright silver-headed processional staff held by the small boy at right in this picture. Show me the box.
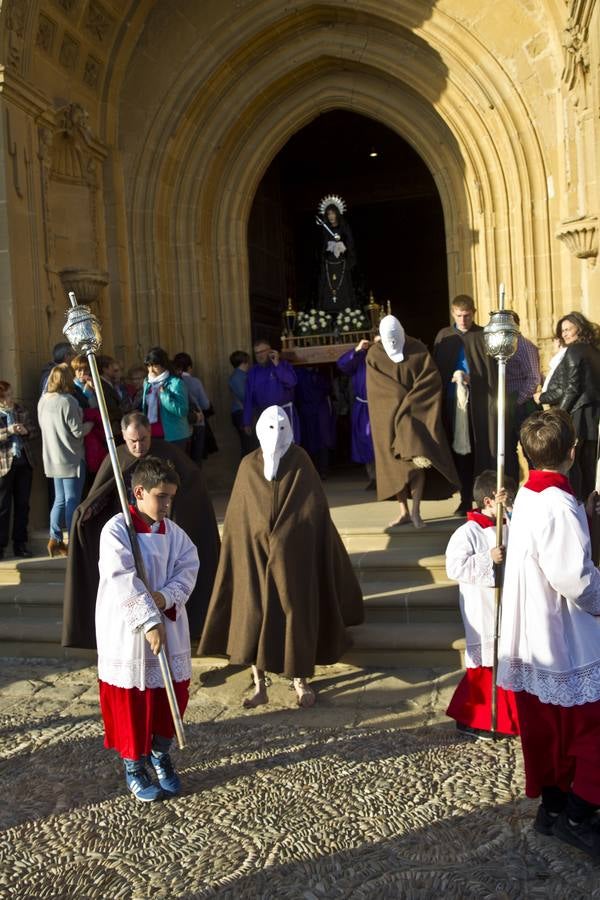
[483,284,519,731]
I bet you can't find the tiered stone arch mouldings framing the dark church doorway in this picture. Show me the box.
[117,7,552,404]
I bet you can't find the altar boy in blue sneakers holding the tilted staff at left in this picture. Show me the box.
[96,456,198,802]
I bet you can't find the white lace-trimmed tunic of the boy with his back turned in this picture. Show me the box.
[498,487,600,706]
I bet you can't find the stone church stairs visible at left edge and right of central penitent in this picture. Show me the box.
[0,511,464,668]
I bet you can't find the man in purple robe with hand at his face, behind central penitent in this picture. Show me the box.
[243,338,300,444]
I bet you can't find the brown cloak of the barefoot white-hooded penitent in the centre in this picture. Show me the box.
[198,444,364,677]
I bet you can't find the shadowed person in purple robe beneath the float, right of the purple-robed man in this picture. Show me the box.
[295,366,335,479]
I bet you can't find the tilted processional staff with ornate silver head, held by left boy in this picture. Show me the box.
[63,291,185,750]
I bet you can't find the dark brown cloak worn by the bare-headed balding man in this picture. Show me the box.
[62,438,220,649]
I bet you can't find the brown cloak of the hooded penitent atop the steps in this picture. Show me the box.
[367,335,459,500]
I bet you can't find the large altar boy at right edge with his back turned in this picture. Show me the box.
[498,409,600,859]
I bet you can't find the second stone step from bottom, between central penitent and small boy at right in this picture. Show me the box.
[363,581,461,623]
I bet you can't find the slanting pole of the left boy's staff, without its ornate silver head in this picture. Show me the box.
[67,291,185,750]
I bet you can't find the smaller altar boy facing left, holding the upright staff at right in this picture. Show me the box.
[446,469,519,739]
